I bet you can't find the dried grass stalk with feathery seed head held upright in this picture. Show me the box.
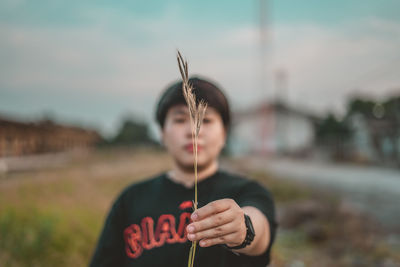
[177,51,207,267]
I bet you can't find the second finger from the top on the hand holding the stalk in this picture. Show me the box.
[187,210,235,233]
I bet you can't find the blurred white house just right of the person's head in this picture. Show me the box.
[229,103,317,155]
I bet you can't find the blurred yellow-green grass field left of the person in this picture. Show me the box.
[0,151,170,267]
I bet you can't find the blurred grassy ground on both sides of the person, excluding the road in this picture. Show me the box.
[0,150,400,267]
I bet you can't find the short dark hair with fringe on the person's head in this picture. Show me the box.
[156,77,231,130]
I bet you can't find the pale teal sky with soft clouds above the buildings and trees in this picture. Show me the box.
[0,0,400,136]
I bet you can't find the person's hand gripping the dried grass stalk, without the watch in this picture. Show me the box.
[186,199,246,247]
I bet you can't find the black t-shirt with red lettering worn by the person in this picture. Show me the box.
[90,170,276,267]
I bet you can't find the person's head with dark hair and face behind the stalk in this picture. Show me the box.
[156,78,230,172]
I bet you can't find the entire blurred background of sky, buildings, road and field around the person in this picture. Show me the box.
[0,0,400,267]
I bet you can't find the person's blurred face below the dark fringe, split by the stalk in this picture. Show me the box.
[162,104,226,171]
